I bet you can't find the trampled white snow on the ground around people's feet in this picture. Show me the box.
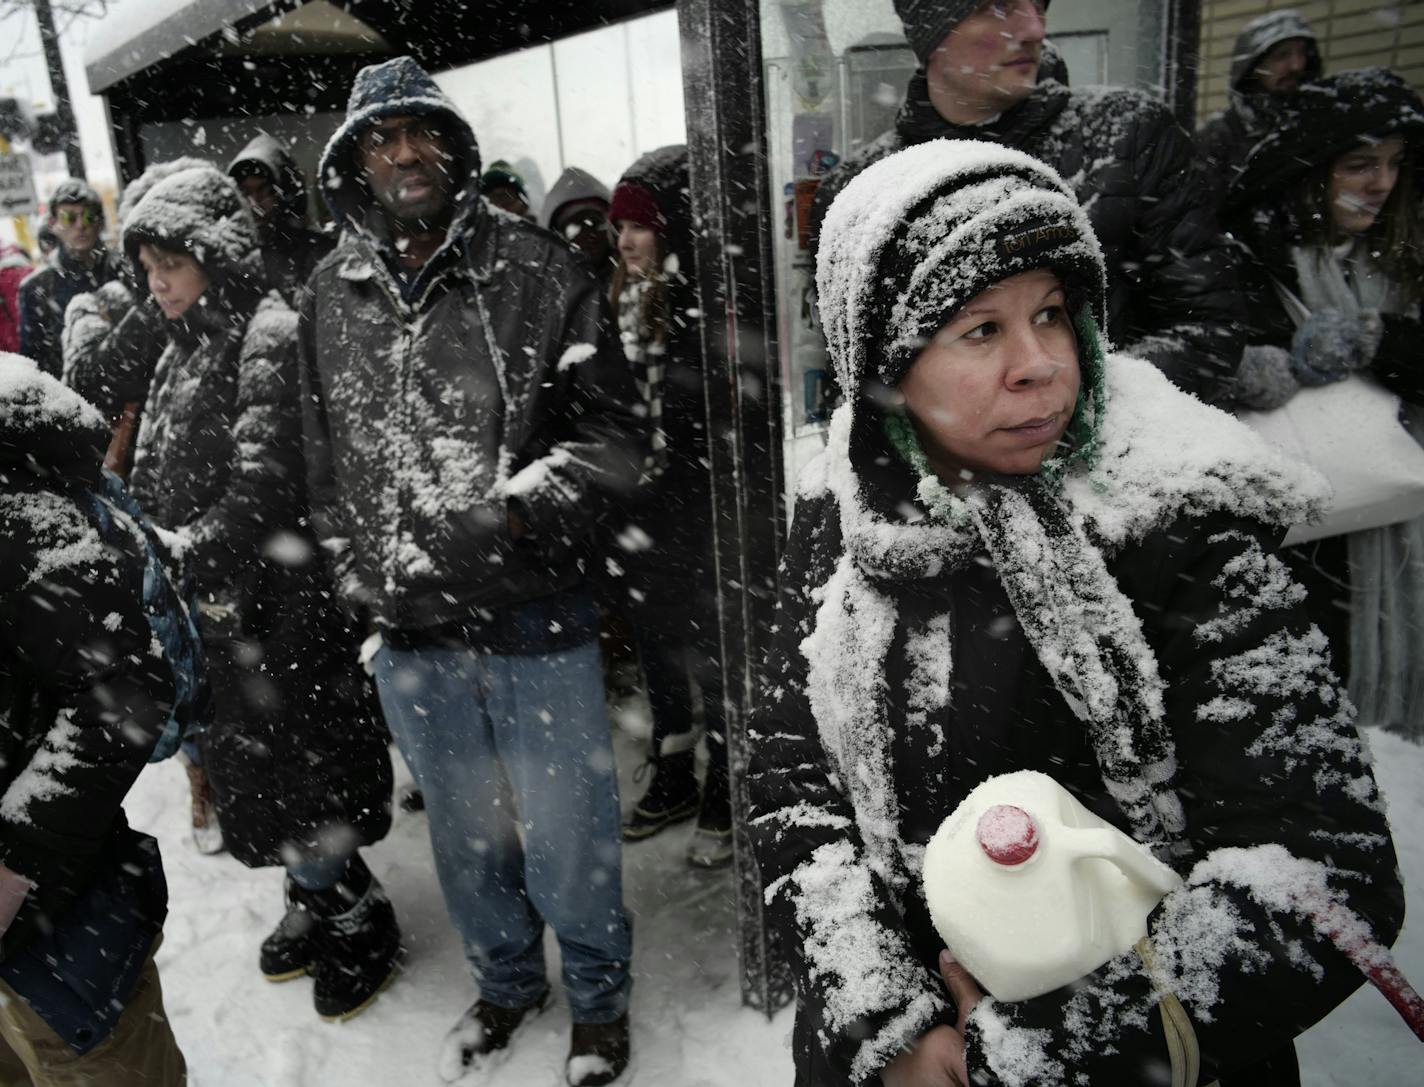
[127,722,1424,1087]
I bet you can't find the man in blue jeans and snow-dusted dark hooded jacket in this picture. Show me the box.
[300,57,644,1086]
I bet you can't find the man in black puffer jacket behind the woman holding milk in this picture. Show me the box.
[812,0,1243,402]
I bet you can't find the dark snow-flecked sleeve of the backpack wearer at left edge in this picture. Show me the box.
[0,492,174,912]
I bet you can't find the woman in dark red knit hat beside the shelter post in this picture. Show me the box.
[608,144,732,868]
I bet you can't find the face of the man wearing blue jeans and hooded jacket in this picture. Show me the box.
[356,117,454,224]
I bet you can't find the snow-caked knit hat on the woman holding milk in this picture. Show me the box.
[816,140,1106,392]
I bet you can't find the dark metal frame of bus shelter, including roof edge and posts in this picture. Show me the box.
[88,0,1200,1014]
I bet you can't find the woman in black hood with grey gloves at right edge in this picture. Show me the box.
[1227,68,1424,735]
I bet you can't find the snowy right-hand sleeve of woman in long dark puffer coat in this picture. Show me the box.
[184,295,302,586]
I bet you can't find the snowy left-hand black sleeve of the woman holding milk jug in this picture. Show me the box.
[748,496,954,1087]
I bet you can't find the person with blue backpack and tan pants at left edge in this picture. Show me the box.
[0,353,206,1087]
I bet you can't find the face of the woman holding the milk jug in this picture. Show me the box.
[899,269,1079,483]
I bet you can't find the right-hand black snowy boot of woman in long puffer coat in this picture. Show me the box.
[293,856,400,1020]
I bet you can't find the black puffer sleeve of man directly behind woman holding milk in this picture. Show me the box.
[1112,104,1245,403]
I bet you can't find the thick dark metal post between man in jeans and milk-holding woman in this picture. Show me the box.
[678,0,792,1016]
